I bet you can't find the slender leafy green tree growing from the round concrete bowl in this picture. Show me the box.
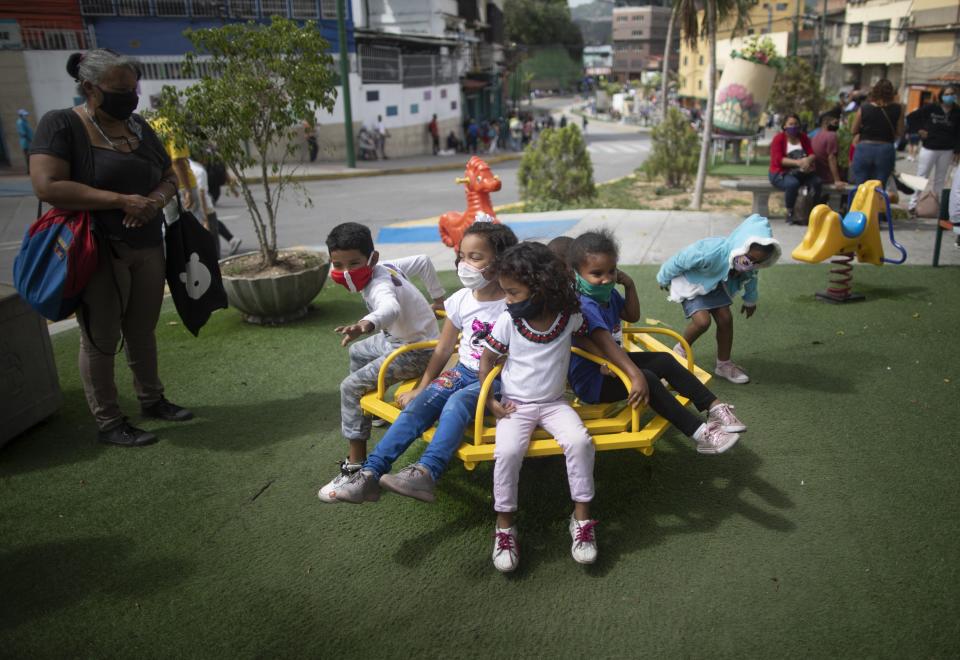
[158,16,337,269]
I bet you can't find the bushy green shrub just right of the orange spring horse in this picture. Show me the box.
[517,123,597,211]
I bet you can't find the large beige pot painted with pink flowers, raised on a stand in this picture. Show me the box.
[713,57,777,135]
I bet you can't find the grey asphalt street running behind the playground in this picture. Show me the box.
[0,100,650,281]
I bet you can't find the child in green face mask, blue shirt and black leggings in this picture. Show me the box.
[568,231,747,454]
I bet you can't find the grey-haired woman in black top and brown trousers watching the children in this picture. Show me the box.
[30,48,193,447]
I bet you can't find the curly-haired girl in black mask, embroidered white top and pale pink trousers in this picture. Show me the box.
[479,242,597,572]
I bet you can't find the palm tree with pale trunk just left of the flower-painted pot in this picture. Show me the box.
[674,0,753,211]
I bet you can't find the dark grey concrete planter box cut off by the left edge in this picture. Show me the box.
[0,284,63,447]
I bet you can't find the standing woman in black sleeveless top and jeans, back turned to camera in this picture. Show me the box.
[851,78,903,188]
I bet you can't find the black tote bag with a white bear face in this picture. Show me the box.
[164,195,227,337]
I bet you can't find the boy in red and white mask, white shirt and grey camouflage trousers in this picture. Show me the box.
[318,222,444,503]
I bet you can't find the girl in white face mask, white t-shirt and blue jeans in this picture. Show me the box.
[334,220,517,504]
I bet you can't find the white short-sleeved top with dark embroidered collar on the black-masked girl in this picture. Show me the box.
[485,312,587,403]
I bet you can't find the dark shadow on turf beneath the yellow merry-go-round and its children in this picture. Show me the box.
[386,433,796,580]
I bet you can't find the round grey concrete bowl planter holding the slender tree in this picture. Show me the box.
[220,250,330,324]
